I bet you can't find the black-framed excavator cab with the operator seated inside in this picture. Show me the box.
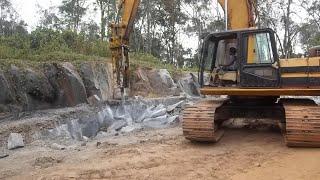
[200,29,280,88]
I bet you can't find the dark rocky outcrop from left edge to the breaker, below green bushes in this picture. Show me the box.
[0,62,112,113]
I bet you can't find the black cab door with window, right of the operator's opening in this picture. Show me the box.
[240,30,280,88]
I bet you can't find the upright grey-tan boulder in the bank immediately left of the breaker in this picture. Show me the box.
[80,62,113,101]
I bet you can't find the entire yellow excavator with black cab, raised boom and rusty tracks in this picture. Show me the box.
[110,0,320,147]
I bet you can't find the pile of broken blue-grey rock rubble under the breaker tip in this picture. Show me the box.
[37,97,185,141]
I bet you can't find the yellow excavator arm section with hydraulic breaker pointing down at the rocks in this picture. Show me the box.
[110,0,140,99]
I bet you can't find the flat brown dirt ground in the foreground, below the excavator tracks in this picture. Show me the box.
[0,127,320,180]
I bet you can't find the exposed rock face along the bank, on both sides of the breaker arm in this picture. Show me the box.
[0,61,200,114]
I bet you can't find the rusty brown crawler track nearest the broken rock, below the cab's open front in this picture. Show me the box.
[182,101,223,142]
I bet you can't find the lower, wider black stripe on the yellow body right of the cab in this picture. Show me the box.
[281,77,320,87]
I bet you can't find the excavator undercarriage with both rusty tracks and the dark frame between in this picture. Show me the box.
[183,97,320,147]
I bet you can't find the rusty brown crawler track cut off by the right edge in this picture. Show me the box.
[284,104,320,147]
